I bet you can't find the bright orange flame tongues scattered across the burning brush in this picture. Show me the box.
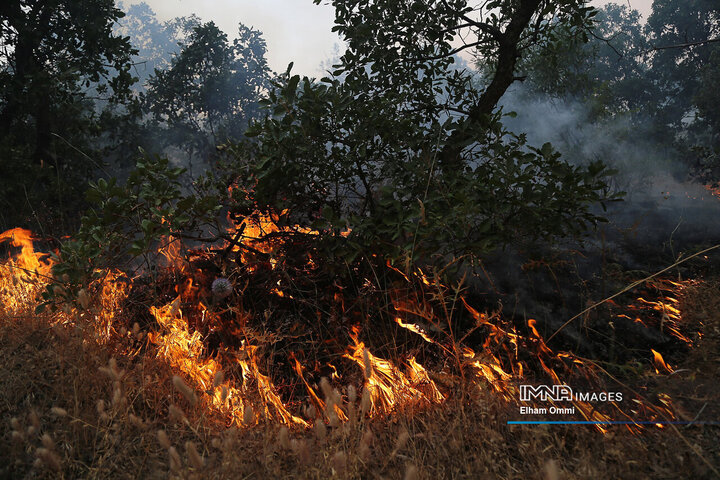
[0,223,689,430]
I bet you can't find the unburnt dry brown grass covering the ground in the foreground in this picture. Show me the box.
[0,281,720,480]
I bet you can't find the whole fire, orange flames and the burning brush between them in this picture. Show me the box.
[0,221,689,430]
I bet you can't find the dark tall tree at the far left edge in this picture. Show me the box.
[0,0,133,231]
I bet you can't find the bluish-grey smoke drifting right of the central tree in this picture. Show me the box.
[503,86,720,253]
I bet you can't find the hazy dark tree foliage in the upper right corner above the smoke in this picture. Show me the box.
[522,0,720,177]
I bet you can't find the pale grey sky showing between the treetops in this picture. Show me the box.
[122,0,652,76]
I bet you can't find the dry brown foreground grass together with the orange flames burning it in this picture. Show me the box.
[0,227,720,479]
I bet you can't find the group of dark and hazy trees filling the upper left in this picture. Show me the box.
[0,0,271,232]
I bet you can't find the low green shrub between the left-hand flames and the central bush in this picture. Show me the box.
[43,153,222,312]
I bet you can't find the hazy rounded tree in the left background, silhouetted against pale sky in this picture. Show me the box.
[147,22,269,160]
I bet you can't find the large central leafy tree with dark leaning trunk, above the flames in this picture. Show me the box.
[239,0,616,261]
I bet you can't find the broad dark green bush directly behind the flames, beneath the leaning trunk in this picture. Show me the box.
[233,66,611,261]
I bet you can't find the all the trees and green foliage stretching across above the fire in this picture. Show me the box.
[0,0,720,270]
